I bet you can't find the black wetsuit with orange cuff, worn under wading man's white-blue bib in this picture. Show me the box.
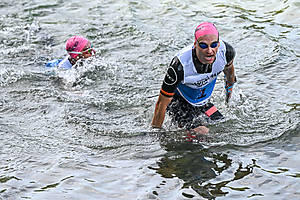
[160,42,235,129]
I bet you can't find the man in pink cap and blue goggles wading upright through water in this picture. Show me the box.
[152,22,236,134]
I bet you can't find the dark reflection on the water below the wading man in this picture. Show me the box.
[151,142,258,199]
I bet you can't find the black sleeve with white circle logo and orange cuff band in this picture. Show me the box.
[160,57,183,97]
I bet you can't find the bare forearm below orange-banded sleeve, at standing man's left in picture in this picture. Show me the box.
[152,93,173,128]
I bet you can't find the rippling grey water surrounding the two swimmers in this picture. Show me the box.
[0,0,300,200]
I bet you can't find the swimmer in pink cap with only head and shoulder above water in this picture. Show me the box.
[46,35,96,69]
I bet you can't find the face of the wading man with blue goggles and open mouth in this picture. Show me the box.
[194,34,220,64]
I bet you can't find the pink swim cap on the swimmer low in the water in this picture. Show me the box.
[66,35,89,58]
